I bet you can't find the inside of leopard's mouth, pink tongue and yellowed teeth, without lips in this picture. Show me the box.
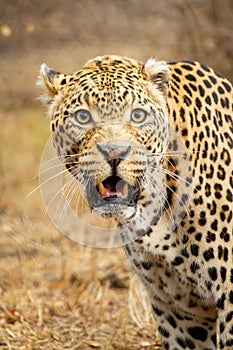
[98,176,128,198]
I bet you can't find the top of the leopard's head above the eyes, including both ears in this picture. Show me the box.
[39,55,170,121]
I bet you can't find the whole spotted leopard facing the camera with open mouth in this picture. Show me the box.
[39,55,233,350]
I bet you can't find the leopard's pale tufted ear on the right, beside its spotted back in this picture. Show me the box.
[143,58,170,95]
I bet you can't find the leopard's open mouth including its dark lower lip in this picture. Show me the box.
[88,176,139,208]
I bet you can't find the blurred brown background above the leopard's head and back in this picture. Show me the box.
[0,0,233,108]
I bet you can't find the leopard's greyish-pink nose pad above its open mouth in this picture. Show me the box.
[96,143,131,162]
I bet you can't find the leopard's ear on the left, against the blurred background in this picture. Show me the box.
[37,63,65,104]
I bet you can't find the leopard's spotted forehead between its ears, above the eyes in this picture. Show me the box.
[60,56,149,110]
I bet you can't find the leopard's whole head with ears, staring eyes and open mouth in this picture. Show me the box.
[37,56,169,223]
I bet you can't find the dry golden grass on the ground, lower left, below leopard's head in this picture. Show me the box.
[0,216,160,350]
